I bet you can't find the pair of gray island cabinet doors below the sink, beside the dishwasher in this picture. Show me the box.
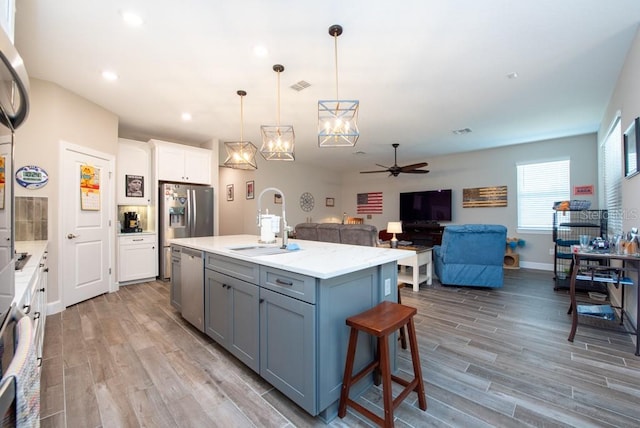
[205,269,260,373]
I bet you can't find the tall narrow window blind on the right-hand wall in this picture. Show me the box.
[600,117,623,236]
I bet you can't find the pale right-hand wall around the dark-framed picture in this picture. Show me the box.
[598,25,640,324]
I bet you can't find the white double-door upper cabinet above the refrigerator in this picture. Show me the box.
[150,140,211,184]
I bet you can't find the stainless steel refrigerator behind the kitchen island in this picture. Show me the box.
[158,182,213,281]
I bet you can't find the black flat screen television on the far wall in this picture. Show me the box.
[400,189,451,224]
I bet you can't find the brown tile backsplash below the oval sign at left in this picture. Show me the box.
[15,196,49,241]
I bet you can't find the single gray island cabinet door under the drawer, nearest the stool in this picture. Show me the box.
[260,288,317,415]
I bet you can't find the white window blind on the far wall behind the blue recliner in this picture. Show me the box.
[517,159,571,230]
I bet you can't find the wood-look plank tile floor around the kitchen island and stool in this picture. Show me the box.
[41,269,640,428]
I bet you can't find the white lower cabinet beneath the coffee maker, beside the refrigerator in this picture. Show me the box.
[118,233,158,284]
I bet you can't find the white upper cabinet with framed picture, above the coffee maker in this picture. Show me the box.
[116,138,153,205]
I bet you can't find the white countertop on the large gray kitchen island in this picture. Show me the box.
[169,235,411,279]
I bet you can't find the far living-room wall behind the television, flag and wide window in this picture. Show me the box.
[341,134,598,269]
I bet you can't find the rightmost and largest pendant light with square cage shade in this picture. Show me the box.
[318,25,360,147]
